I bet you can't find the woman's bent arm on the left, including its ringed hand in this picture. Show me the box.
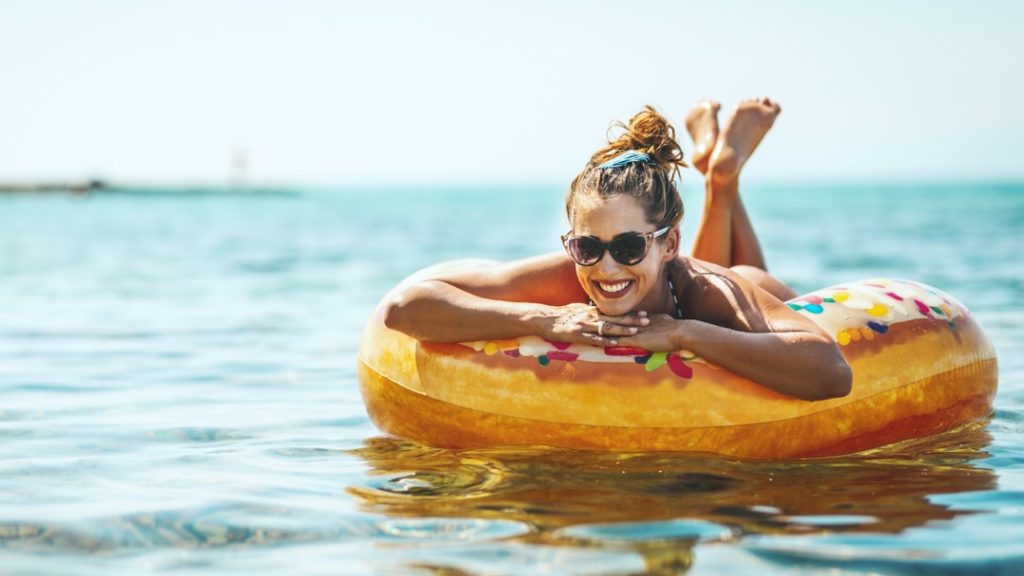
[384,253,640,345]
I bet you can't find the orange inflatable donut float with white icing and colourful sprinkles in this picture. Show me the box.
[358,261,997,459]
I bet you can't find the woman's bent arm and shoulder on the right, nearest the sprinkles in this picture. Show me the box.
[622,266,853,400]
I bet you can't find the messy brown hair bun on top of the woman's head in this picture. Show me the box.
[591,105,686,174]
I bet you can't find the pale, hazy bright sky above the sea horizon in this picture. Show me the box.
[0,0,1024,186]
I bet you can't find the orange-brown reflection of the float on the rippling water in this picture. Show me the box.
[348,424,996,574]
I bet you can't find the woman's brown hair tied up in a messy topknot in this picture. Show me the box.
[565,105,686,228]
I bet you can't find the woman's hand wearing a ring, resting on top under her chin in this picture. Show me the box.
[542,303,649,346]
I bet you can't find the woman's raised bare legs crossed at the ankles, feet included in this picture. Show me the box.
[686,98,796,299]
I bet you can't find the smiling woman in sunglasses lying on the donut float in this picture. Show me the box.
[385,98,852,400]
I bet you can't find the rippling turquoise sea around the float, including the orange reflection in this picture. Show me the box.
[0,184,1024,575]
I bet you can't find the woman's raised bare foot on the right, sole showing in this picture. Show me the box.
[710,98,782,181]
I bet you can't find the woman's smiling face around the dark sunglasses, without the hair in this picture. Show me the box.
[571,194,679,316]
